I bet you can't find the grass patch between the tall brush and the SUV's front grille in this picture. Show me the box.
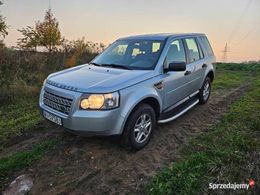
[0,97,43,143]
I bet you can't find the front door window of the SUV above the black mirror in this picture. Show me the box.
[166,40,186,64]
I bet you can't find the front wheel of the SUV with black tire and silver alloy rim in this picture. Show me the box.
[121,104,156,151]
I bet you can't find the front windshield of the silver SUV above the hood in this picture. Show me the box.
[91,40,164,70]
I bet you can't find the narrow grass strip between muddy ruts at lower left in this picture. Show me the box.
[0,139,57,191]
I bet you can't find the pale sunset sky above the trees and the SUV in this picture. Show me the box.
[0,0,260,62]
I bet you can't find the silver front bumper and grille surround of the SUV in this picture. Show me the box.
[39,84,125,135]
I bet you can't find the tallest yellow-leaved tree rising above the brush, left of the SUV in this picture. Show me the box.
[36,9,63,52]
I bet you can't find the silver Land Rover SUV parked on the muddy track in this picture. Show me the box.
[39,33,215,150]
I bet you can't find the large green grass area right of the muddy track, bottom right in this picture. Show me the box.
[145,67,260,194]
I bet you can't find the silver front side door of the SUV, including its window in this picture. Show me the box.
[163,39,189,110]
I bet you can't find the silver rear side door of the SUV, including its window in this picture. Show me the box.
[184,37,206,94]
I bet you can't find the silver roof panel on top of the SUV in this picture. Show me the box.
[118,33,205,41]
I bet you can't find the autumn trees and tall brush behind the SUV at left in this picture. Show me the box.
[0,0,106,100]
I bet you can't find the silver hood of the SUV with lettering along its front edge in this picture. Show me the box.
[47,65,154,93]
